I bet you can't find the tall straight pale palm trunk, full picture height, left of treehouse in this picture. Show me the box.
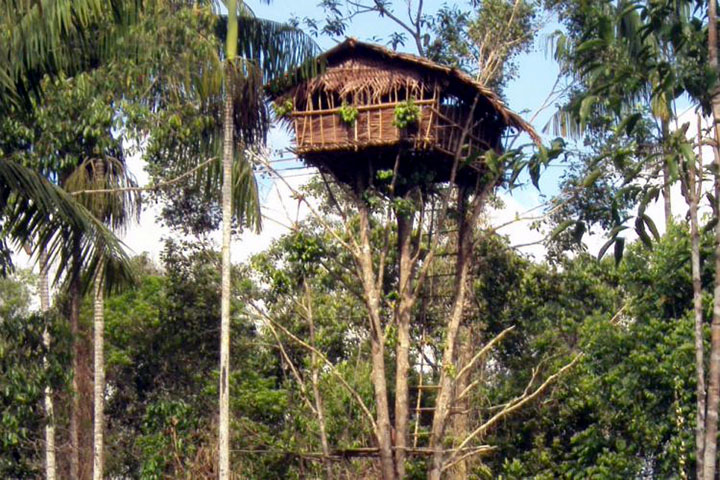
[218,0,238,480]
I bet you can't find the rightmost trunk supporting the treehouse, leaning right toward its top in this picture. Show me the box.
[428,188,485,480]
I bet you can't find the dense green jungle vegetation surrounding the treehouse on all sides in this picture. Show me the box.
[0,0,720,480]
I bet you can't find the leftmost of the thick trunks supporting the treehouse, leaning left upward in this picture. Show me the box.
[357,201,395,480]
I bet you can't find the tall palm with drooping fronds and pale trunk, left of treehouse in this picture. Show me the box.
[139,6,318,472]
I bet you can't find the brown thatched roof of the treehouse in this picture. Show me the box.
[273,38,541,144]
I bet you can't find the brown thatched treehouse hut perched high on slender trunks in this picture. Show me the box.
[271,38,538,188]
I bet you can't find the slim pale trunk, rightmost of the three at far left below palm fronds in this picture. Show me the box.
[93,260,105,480]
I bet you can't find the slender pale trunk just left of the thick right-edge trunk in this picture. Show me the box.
[687,116,705,480]
